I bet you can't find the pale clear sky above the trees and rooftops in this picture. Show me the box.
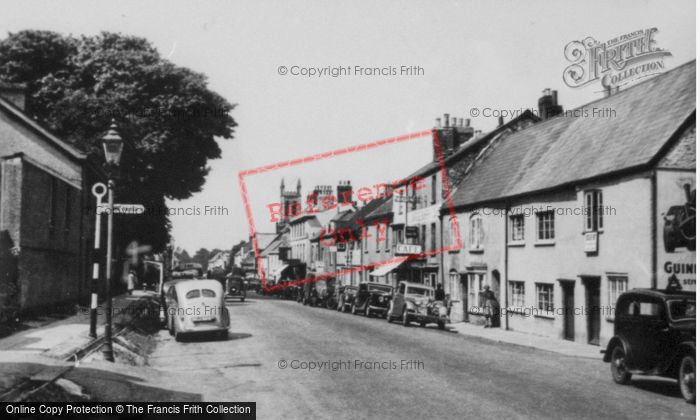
[0,0,696,253]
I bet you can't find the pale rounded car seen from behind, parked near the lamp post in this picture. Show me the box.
[166,280,230,341]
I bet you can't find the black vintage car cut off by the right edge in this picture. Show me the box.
[603,289,695,403]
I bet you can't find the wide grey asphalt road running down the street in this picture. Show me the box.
[139,298,695,419]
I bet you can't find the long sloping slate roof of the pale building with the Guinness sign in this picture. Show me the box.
[443,60,695,208]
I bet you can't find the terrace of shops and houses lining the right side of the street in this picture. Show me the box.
[243,61,696,345]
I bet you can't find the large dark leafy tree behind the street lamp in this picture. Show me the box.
[0,31,237,249]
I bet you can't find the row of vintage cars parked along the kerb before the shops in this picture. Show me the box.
[298,281,449,329]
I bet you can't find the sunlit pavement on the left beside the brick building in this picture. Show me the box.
[0,291,153,400]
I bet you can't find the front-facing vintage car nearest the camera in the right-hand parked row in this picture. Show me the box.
[386,281,449,330]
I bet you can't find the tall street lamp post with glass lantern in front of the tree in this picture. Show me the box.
[102,120,124,362]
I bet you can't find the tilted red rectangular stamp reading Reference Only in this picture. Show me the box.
[238,129,462,292]
